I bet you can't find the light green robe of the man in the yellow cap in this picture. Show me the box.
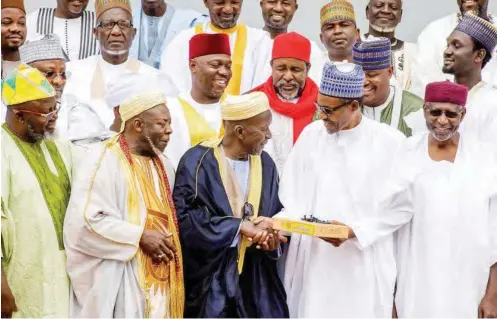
[1,127,72,318]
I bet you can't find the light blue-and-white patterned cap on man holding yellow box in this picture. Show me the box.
[319,62,364,99]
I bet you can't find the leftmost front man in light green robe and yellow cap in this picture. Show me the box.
[1,64,72,318]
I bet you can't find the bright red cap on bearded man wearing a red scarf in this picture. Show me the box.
[271,32,311,63]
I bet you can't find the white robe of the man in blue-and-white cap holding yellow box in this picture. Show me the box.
[279,117,404,318]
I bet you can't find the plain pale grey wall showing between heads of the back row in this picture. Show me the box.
[24,0,497,44]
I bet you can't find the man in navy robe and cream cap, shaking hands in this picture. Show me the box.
[173,92,288,318]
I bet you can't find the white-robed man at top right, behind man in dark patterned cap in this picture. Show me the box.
[411,0,497,97]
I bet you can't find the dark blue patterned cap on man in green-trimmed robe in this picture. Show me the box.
[352,36,392,71]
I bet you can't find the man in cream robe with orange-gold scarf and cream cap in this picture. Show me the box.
[64,93,184,318]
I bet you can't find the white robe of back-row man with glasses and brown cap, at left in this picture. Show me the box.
[64,55,167,145]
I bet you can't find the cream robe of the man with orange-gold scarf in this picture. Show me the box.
[64,144,174,318]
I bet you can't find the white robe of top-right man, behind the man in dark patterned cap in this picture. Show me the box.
[411,14,497,98]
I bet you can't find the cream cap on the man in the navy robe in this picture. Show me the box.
[221,92,269,121]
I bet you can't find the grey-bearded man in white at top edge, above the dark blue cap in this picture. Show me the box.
[363,0,417,91]
